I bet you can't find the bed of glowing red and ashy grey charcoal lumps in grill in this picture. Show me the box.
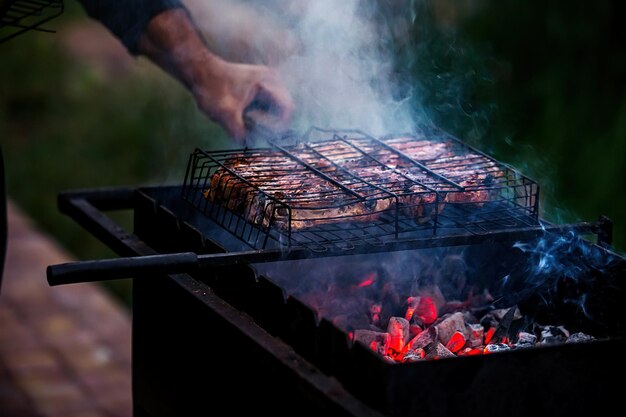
[270,252,593,363]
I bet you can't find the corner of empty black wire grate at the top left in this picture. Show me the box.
[0,0,63,43]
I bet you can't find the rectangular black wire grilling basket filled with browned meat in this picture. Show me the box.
[183,128,539,252]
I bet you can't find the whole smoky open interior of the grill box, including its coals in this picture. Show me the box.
[258,234,617,362]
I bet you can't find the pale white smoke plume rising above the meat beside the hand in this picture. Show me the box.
[186,0,415,134]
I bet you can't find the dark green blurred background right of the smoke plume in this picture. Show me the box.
[397,0,626,247]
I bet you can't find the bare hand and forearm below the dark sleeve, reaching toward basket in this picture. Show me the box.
[139,9,293,142]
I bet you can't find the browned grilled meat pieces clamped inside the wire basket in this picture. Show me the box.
[204,137,505,230]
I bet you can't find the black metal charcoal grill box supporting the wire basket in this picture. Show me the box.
[45,186,626,417]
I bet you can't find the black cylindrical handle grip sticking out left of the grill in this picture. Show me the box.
[46,252,198,286]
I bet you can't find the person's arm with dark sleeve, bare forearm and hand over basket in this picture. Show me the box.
[80,0,293,140]
